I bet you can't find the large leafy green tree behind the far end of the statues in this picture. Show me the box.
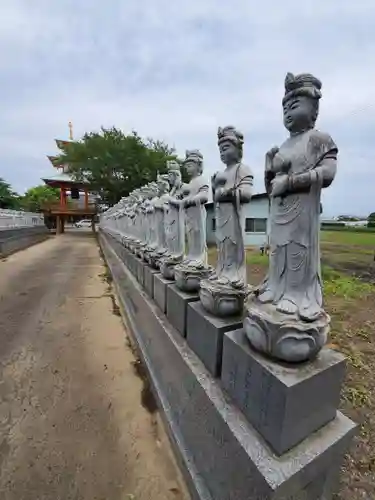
[54,127,181,205]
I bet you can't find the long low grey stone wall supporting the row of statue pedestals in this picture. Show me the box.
[99,231,355,500]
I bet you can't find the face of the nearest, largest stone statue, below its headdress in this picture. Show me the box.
[283,96,316,132]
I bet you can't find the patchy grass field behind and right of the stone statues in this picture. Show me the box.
[209,231,375,500]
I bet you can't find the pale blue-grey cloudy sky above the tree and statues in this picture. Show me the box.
[0,0,375,215]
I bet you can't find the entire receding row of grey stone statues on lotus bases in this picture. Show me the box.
[101,73,338,362]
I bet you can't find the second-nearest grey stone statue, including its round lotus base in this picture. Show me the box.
[200,126,253,316]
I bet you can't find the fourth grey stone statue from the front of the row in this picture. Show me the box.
[160,160,185,280]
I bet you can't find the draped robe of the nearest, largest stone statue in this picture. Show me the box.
[261,130,337,320]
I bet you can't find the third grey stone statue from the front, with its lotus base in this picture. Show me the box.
[174,150,212,292]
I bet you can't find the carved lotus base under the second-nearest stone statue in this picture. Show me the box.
[199,280,249,318]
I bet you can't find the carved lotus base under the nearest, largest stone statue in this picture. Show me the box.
[244,296,330,363]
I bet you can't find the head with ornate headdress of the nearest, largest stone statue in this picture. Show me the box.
[283,73,322,133]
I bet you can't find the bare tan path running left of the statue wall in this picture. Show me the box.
[0,233,188,500]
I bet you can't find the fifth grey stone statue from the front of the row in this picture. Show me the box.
[150,174,169,269]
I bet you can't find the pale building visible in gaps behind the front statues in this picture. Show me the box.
[206,193,269,247]
